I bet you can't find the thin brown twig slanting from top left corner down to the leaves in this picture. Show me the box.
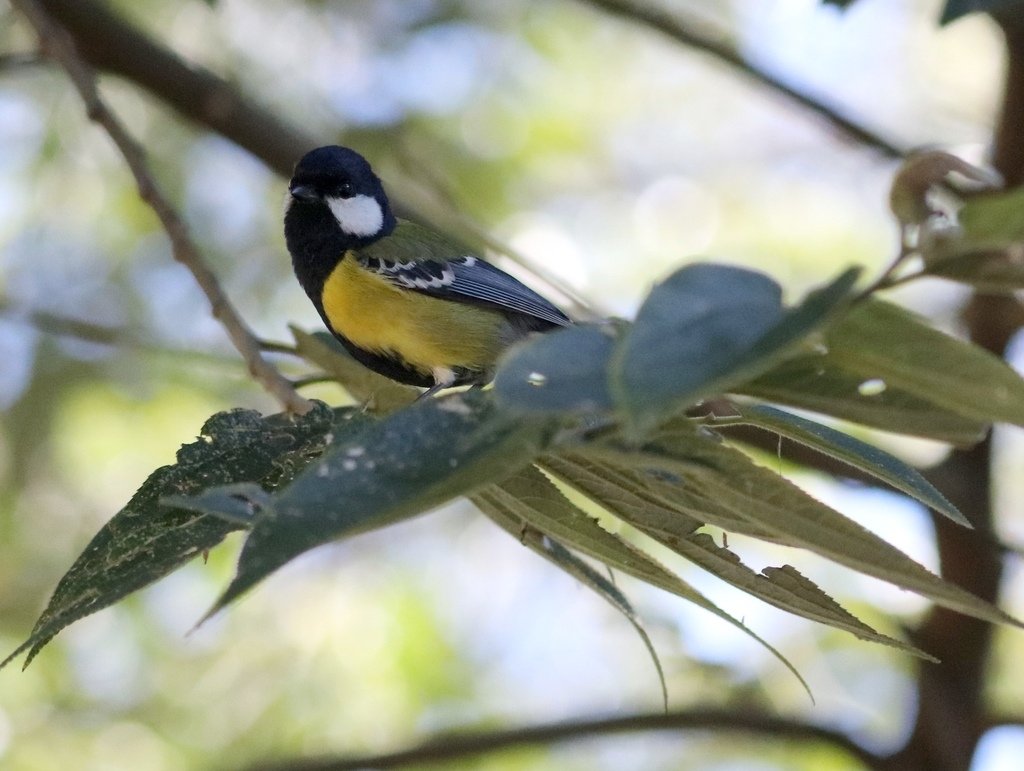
[12,0,312,415]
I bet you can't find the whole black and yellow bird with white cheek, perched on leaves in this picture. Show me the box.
[285,145,571,395]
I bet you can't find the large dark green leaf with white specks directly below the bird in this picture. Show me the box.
[196,391,550,613]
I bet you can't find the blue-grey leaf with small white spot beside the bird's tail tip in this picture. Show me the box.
[495,325,615,414]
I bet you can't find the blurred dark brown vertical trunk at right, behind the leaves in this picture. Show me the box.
[892,12,1024,771]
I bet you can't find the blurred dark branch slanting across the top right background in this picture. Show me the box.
[581,0,906,158]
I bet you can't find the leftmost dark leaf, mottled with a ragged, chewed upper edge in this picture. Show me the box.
[0,402,342,667]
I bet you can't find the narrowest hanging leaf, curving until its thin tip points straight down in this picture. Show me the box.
[470,487,669,710]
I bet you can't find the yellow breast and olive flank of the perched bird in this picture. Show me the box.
[323,255,504,375]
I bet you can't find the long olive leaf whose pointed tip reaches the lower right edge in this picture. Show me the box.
[583,438,1024,626]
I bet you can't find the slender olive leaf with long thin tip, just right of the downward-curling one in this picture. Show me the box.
[475,469,813,700]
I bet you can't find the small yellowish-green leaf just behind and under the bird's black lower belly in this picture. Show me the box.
[289,326,420,413]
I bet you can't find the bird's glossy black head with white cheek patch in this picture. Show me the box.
[285,145,395,256]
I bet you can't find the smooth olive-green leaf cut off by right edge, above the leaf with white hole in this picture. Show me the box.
[827,299,1024,425]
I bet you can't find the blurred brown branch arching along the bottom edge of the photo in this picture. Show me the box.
[249,710,891,771]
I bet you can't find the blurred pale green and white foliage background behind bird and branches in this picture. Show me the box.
[0,0,1024,771]
